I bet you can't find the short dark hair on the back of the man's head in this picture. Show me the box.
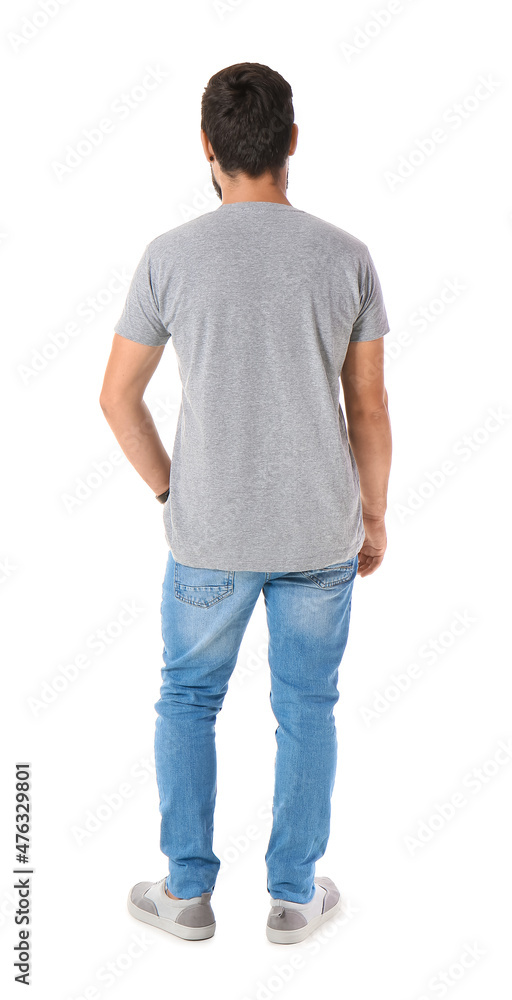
[201,63,294,182]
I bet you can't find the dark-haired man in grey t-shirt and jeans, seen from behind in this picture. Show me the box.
[100,63,391,944]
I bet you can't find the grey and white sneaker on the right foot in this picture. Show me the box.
[267,877,341,944]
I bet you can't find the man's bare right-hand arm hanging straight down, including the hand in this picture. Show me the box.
[341,337,392,576]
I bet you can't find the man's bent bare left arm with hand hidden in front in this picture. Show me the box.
[99,333,171,496]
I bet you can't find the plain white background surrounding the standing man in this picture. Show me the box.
[0,0,512,1000]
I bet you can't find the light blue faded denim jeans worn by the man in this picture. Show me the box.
[155,550,358,903]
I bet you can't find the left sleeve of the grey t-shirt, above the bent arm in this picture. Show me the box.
[114,246,171,347]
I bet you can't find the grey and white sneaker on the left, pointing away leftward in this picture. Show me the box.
[128,875,215,941]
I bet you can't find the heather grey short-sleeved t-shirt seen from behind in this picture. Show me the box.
[115,201,389,573]
